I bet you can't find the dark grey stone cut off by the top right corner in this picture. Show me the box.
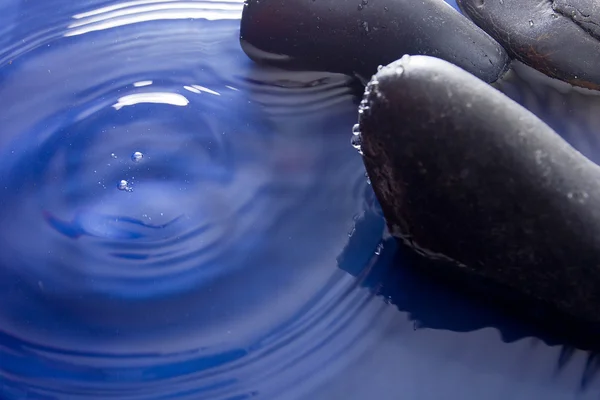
[457,0,600,90]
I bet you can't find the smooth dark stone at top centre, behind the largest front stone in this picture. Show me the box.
[240,0,510,83]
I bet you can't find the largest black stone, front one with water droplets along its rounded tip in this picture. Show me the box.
[359,56,600,325]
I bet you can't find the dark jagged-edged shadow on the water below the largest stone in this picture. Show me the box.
[338,188,600,391]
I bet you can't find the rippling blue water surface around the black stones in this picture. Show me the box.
[0,0,600,400]
